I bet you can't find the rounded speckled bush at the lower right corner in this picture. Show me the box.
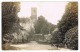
[64,26,78,50]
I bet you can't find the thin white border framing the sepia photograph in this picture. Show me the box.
[0,0,80,52]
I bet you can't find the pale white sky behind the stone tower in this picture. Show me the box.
[18,2,68,25]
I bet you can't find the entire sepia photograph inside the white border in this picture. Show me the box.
[1,1,78,50]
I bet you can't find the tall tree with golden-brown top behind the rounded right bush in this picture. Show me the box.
[58,2,78,40]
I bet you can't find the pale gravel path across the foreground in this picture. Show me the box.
[11,41,70,50]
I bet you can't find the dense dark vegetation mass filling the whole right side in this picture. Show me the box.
[53,2,78,49]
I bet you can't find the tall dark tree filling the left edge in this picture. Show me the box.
[2,2,19,49]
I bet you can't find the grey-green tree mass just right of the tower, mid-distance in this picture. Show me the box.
[35,16,55,34]
